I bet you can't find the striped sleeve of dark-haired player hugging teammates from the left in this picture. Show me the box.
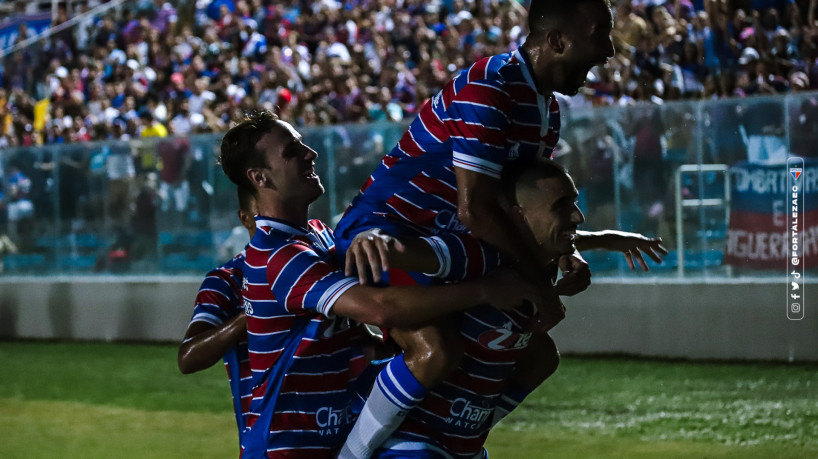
[267,241,358,317]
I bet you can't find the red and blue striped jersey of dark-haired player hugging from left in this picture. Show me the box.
[242,216,366,457]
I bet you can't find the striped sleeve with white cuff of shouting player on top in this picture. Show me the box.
[445,80,511,179]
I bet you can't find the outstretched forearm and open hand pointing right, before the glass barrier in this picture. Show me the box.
[575,230,667,271]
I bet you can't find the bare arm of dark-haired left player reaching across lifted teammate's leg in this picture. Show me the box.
[332,269,542,328]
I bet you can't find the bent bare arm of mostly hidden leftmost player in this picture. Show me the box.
[176,312,247,374]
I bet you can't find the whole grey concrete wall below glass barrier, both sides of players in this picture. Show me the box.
[0,277,818,362]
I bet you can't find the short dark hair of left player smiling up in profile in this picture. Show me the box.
[219,111,279,193]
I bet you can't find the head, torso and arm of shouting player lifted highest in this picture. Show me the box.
[336,0,614,292]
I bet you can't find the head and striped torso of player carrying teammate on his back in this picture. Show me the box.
[374,160,584,458]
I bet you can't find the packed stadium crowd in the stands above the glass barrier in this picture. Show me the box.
[0,0,818,148]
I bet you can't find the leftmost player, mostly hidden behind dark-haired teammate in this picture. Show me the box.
[177,184,256,450]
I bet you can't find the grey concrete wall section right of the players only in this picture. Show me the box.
[552,278,818,362]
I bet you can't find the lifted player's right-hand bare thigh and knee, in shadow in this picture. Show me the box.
[491,333,560,427]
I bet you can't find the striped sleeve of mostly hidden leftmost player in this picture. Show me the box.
[190,267,243,326]
